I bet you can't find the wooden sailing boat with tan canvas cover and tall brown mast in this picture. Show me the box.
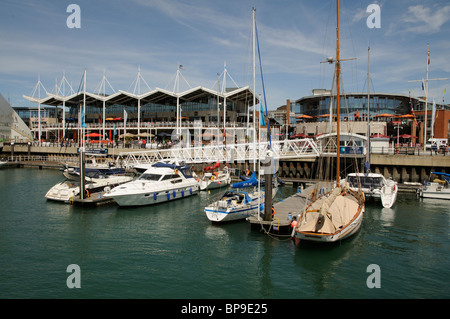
[292,0,365,245]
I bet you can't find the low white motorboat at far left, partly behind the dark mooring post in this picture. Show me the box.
[45,174,134,203]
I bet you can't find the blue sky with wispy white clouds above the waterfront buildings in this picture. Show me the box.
[0,0,450,110]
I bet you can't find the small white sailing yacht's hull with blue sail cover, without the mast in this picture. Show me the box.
[205,173,264,223]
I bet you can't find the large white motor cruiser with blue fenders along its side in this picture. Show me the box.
[104,160,200,206]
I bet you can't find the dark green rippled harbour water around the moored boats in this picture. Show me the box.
[0,168,450,299]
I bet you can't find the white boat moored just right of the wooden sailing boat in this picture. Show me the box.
[343,172,398,208]
